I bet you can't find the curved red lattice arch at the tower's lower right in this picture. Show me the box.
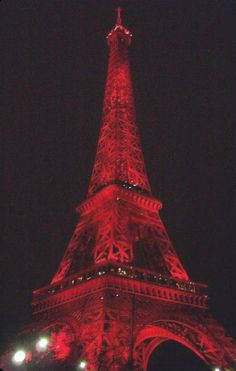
[134,319,236,370]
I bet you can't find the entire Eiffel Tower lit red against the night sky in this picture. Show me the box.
[2,9,236,371]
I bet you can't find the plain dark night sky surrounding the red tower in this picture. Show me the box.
[0,0,236,368]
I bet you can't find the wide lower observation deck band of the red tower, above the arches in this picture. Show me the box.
[32,263,208,314]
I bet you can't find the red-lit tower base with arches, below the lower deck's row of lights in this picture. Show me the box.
[6,284,236,371]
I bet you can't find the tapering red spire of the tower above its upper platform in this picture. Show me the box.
[88,7,151,196]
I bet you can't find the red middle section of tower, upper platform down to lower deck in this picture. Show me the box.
[52,185,188,283]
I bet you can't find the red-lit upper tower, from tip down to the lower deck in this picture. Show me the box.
[52,10,188,283]
